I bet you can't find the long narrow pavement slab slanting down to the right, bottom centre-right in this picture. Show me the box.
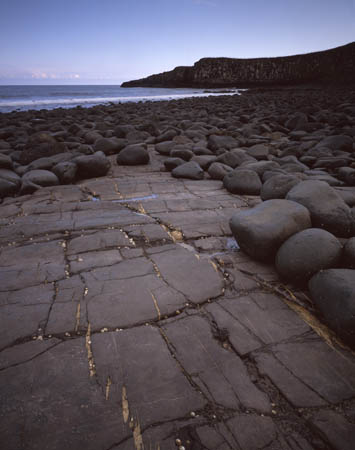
[163,316,271,412]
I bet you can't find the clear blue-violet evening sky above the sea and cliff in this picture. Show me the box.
[0,0,355,85]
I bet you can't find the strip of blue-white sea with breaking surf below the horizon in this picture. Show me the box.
[0,85,242,112]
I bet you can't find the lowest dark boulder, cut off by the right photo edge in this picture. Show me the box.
[308,269,355,348]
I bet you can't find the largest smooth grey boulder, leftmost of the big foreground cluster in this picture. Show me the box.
[230,199,311,261]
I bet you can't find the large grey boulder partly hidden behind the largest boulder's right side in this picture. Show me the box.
[286,180,353,237]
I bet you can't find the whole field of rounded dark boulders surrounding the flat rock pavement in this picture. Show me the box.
[0,87,355,347]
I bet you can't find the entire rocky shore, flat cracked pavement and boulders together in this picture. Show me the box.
[0,86,355,450]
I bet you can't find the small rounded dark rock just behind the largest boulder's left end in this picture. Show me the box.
[223,168,261,195]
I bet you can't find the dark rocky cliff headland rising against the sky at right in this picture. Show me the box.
[122,42,355,88]
